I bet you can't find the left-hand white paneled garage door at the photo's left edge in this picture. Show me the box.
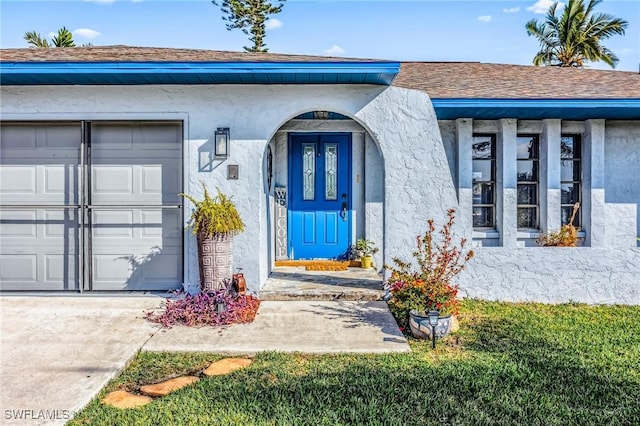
[0,123,82,290]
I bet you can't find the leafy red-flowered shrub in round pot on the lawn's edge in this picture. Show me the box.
[385,209,474,339]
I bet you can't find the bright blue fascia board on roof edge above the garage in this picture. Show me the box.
[0,62,400,85]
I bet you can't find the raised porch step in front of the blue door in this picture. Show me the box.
[260,266,384,301]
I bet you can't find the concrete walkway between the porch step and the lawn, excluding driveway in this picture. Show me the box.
[142,301,410,354]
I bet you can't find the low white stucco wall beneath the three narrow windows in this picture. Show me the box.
[459,247,640,305]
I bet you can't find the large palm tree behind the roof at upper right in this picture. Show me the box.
[526,0,629,68]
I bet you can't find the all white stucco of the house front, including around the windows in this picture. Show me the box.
[1,85,640,303]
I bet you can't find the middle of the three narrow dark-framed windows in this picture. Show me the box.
[517,135,540,229]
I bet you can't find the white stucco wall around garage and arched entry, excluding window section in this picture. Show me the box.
[2,85,455,292]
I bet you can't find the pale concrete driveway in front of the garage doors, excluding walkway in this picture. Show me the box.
[0,295,163,425]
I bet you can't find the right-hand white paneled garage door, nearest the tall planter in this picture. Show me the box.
[91,123,182,290]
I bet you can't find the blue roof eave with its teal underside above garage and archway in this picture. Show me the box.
[0,61,400,86]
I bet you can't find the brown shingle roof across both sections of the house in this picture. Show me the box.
[0,46,640,99]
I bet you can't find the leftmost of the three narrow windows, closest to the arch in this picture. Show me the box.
[471,135,496,229]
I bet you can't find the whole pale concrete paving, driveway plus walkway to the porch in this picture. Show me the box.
[0,295,410,425]
